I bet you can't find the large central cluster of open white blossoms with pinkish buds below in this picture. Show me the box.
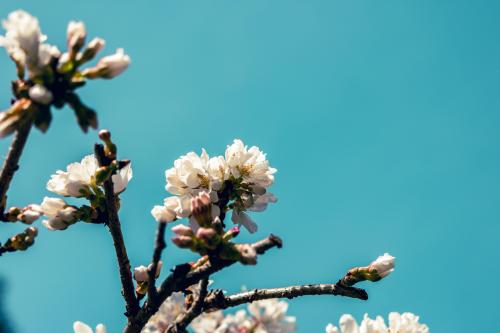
[151,140,276,264]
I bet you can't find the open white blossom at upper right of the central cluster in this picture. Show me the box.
[225,139,277,188]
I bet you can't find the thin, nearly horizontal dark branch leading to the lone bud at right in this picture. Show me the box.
[204,281,368,311]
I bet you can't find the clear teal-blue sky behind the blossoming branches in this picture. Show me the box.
[0,0,500,333]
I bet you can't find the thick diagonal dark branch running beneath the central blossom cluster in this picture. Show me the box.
[124,235,282,333]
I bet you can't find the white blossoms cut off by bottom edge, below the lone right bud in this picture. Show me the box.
[325,312,429,333]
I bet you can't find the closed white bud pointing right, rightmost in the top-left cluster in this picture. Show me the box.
[82,49,130,79]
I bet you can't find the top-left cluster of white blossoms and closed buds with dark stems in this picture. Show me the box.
[0,10,130,136]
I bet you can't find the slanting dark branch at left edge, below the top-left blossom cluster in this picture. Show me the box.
[0,120,32,215]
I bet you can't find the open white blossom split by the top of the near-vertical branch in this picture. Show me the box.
[47,155,132,198]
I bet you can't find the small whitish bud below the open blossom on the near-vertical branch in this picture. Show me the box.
[40,197,78,231]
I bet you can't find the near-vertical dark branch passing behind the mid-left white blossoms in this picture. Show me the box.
[95,144,140,319]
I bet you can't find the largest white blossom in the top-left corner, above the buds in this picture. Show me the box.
[0,10,46,70]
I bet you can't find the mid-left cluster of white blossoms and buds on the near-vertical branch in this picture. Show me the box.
[32,155,132,230]
